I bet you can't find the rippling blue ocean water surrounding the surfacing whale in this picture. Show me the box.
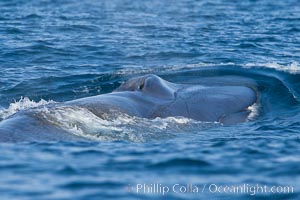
[0,0,300,199]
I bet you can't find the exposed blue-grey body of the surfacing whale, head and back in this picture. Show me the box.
[0,75,256,142]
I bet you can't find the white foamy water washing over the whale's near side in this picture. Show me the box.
[37,107,216,142]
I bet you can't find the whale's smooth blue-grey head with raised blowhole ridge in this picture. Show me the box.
[114,74,256,123]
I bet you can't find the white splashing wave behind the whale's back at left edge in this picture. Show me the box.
[0,97,55,120]
